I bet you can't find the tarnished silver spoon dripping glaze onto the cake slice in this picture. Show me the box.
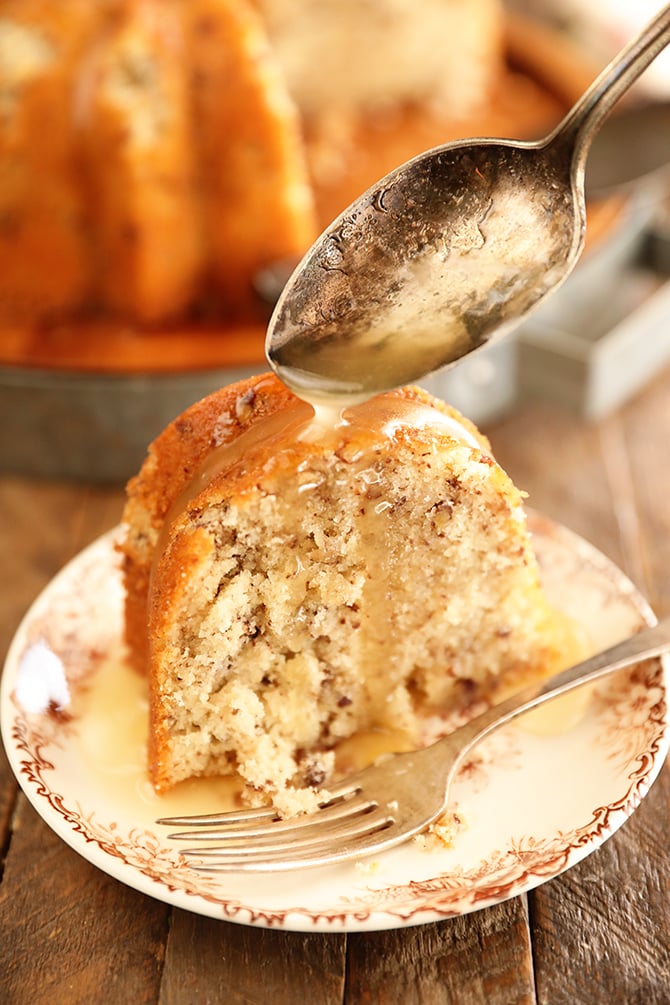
[265,5,670,401]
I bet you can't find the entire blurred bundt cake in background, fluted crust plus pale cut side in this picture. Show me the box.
[0,0,532,332]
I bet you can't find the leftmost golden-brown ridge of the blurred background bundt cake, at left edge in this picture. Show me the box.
[0,0,100,320]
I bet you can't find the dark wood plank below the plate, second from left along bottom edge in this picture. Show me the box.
[160,911,347,1005]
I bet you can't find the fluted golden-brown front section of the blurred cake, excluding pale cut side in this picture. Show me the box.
[0,0,315,324]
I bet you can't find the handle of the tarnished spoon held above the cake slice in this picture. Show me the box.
[546,4,670,167]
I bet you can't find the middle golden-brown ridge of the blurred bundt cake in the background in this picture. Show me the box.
[80,0,204,324]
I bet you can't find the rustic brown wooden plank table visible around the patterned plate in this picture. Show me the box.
[0,372,670,1005]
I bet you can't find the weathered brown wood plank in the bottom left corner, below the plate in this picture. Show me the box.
[0,796,170,1005]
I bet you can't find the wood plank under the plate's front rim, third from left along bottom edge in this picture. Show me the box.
[346,896,535,1005]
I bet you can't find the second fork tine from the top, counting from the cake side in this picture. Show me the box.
[163,793,378,844]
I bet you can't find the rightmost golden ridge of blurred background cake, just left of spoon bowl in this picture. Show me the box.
[185,0,317,314]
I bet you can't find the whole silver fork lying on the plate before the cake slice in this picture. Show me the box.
[157,617,670,872]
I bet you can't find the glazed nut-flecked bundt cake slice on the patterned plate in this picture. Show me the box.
[120,375,570,813]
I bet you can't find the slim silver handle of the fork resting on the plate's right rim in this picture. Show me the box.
[447,617,670,750]
